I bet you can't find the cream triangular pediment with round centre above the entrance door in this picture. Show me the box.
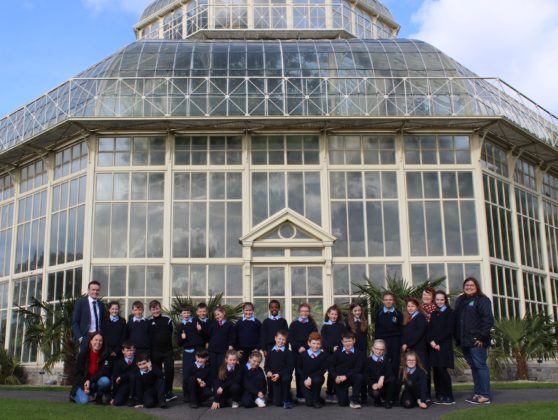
[240,208,336,246]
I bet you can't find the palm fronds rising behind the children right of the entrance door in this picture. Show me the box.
[353,275,446,321]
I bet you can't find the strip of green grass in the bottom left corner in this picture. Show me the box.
[0,398,155,420]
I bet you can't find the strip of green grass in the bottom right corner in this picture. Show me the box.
[442,401,558,420]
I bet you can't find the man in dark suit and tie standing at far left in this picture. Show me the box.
[72,280,105,352]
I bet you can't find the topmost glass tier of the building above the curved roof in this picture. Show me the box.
[134,0,399,39]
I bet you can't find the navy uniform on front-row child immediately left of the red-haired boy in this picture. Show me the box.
[264,345,294,407]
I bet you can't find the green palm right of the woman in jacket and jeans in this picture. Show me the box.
[494,314,558,380]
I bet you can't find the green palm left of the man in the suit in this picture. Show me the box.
[17,297,80,385]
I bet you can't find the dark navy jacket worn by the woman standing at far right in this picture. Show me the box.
[455,294,494,347]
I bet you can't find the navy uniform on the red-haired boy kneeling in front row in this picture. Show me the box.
[297,349,328,407]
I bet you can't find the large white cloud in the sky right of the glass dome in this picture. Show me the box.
[411,0,558,114]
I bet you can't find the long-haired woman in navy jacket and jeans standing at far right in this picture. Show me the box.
[455,277,494,404]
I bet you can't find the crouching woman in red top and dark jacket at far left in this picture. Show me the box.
[70,333,110,404]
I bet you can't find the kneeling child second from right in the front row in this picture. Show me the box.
[365,340,397,409]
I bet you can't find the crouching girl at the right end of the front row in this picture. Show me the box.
[400,351,428,408]
